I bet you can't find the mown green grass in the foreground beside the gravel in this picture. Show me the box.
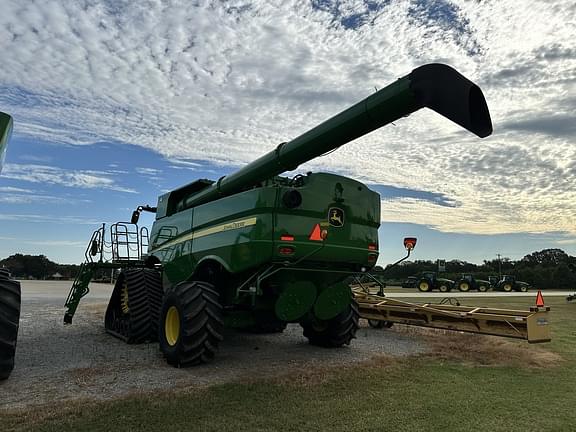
[0,298,576,432]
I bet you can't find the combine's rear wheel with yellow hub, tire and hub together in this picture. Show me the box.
[158,281,224,367]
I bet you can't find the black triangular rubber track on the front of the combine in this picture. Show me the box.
[104,268,163,344]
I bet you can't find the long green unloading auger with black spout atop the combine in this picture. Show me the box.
[176,64,492,211]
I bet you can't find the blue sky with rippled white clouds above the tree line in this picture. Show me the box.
[0,0,576,265]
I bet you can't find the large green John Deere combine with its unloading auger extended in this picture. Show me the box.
[64,64,492,366]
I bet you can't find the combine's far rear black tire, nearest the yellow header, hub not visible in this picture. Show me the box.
[301,300,360,348]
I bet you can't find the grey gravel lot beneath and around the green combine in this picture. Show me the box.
[0,283,427,411]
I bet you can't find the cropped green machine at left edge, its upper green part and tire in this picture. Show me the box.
[0,112,21,380]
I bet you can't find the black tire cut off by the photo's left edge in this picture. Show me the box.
[0,270,21,380]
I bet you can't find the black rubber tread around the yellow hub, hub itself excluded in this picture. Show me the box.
[162,281,224,367]
